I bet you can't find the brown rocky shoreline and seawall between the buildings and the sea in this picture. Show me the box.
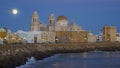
[0,42,120,68]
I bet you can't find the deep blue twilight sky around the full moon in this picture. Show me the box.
[0,0,120,34]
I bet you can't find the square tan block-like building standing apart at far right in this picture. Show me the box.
[103,26,116,42]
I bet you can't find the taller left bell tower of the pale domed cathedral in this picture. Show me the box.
[31,11,39,31]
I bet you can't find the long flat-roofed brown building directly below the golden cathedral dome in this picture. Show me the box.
[56,31,89,43]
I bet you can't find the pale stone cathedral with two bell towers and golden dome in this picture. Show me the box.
[31,11,82,32]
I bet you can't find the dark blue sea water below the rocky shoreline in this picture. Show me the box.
[18,51,120,68]
